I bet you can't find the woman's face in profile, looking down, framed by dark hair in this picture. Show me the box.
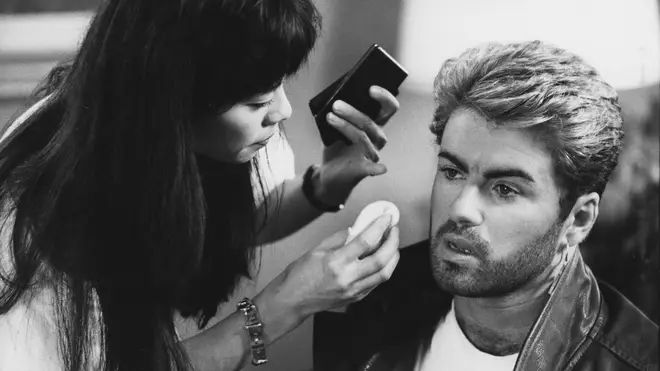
[193,85,291,163]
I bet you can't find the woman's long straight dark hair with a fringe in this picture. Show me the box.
[0,0,320,371]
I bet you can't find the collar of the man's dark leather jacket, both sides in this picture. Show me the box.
[363,249,607,371]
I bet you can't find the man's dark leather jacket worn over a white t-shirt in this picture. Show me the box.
[326,241,658,371]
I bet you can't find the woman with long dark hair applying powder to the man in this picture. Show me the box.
[0,0,398,370]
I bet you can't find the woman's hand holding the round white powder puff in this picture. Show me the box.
[255,215,399,329]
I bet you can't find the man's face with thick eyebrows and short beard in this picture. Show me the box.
[431,110,562,297]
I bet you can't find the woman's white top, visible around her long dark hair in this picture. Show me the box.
[0,98,295,371]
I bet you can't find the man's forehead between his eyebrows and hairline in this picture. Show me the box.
[440,110,552,182]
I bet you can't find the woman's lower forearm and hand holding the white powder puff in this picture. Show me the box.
[183,216,399,371]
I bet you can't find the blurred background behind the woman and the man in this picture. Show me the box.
[0,0,660,371]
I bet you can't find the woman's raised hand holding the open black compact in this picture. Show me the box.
[315,86,399,205]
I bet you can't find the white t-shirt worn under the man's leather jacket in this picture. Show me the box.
[416,302,518,371]
